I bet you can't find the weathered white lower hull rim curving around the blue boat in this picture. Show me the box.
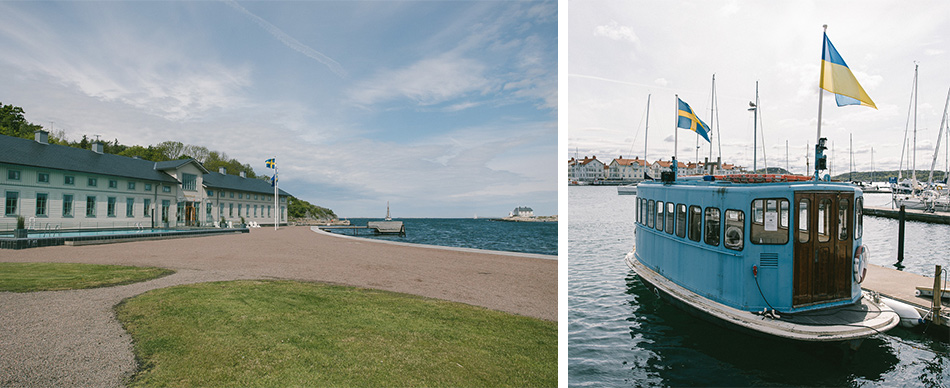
[625,251,900,342]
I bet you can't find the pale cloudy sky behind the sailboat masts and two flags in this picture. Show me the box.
[561,0,950,179]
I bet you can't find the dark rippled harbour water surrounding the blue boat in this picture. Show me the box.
[568,186,950,387]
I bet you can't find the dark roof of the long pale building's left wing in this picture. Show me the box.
[0,135,178,183]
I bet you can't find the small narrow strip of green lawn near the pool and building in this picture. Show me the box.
[0,263,174,292]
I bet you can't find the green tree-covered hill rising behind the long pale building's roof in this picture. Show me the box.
[0,102,337,219]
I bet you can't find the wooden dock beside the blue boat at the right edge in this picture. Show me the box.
[861,264,950,330]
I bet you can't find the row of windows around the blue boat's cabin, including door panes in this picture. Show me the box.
[637,198,864,250]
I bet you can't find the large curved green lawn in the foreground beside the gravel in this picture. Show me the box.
[116,281,557,387]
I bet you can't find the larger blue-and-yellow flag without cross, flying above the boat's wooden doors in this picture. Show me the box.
[818,33,877,109]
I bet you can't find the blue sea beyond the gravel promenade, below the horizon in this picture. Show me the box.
[328,218,557,255]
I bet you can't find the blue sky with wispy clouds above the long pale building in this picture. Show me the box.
[0,1,562,217]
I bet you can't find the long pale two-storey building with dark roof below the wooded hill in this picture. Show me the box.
[0,131,290,230]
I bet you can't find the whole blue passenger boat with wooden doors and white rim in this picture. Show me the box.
[625,174,900,347]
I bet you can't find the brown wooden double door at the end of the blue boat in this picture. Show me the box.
[792,192,854,306]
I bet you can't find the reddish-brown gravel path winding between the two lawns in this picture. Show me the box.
[0,227,557,387]
